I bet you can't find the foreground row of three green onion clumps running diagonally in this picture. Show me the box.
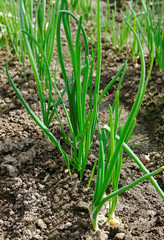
[6,0,164,230]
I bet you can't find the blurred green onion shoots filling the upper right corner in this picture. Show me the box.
[104,0,164,71]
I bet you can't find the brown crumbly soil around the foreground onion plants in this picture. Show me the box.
[0,1,164,240]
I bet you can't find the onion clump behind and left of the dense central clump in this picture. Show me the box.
[20,0,59,131]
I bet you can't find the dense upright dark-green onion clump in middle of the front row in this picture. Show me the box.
[57,0,126,179]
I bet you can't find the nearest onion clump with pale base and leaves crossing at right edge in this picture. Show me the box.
[91,14,164,230]
